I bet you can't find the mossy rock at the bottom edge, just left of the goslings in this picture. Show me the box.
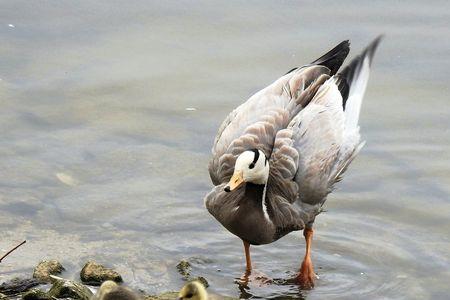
[47,277,93,300]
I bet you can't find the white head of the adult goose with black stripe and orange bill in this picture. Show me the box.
[224,149,269,192]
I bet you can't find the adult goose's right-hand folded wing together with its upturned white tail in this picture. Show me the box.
[269,38,380,213]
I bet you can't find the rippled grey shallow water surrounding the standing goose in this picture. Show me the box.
[0,1,450,299]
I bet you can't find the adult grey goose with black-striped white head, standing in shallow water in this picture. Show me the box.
[204,36,381,289]
